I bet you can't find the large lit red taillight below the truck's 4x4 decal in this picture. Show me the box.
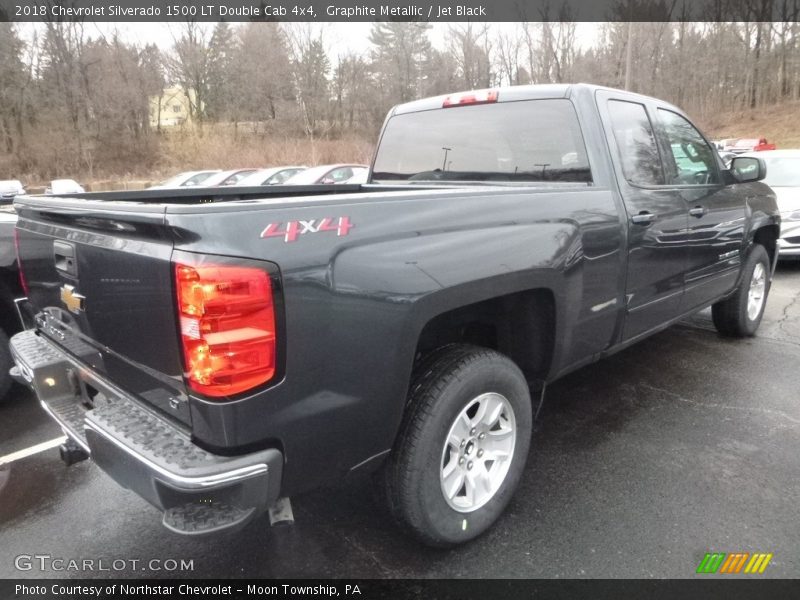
[175,264,275,398]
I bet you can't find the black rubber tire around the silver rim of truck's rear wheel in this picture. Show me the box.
[381,345,532,547]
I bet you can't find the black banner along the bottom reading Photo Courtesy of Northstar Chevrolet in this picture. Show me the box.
[0,577,800,600]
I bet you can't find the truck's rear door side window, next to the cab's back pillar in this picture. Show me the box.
[608,100,664,185]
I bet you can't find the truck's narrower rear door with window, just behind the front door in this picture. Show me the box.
[597,91,688,340]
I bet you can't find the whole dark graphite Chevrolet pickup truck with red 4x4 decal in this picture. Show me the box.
[11,85,780,546]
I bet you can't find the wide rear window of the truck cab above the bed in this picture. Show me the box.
[372,99,592,183]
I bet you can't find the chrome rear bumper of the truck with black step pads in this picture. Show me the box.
[10,330,283,534]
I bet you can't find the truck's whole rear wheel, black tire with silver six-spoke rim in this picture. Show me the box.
[383,345,532,547]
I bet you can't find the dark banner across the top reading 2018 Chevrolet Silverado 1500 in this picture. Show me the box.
[0,0,792,23]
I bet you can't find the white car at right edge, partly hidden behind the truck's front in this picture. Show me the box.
[742,150,800,258]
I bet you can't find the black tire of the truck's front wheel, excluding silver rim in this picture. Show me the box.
[711,244,771,337]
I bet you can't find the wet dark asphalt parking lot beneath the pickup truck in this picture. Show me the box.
[0,263,800,578]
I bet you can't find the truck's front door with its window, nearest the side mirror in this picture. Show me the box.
[656,107,746,312]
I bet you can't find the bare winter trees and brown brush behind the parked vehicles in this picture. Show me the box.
[0,0,800,179]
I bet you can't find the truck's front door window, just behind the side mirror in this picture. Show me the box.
[658,108,720,185]
